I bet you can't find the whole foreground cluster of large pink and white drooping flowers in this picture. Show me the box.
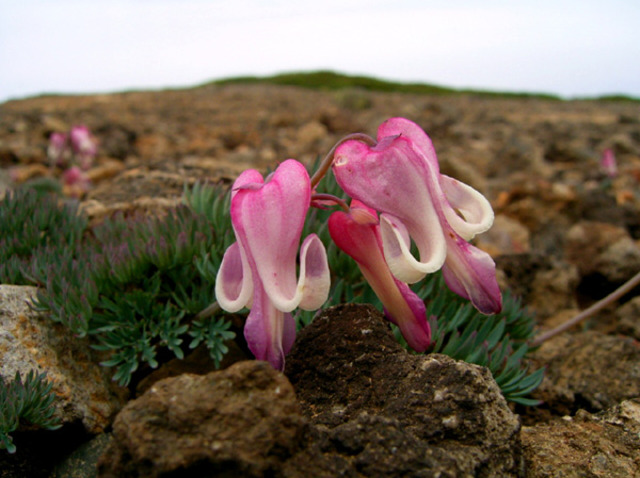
[216,118,502,370]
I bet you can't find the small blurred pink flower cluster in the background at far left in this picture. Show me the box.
[47,126,98,196]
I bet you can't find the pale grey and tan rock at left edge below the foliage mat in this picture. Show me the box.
[0,285,126,433]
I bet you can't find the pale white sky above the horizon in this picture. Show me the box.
[0,0,640,102]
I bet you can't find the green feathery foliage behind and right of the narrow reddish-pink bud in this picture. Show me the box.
[296,160,544,406]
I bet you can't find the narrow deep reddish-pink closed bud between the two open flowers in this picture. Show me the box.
[329,199,431,352]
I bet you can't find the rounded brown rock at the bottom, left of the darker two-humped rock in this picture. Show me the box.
[98,362,305,478]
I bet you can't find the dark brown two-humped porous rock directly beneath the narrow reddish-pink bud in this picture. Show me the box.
[285,305,522,477]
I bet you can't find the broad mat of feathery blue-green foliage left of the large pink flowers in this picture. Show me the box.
[0,186,235,385]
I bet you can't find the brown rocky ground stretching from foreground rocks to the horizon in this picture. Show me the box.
[0,85,640,477]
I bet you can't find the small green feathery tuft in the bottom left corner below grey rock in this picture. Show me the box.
[0,370,61,453]
